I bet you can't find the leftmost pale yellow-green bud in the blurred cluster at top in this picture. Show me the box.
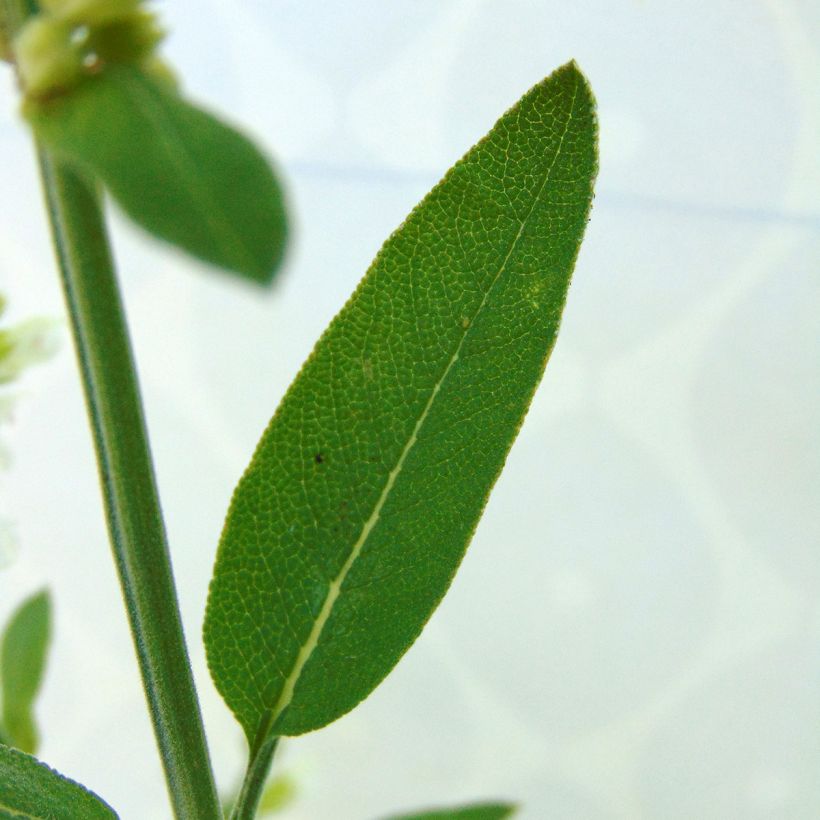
[14,15,83,97]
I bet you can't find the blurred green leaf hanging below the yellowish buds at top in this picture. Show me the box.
[27,65,286,282]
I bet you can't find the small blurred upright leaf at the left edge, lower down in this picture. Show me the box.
[0,590,51,753]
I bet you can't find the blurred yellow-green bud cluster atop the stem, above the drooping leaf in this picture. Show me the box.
[13,0,164,100]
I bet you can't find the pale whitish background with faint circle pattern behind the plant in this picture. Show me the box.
[0,0,820,820]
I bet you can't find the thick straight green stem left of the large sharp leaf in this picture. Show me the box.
[35,151,221,820]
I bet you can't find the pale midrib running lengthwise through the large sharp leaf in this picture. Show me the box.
[255,79,579,748]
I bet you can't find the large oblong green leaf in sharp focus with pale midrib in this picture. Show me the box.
[205,63,597,748]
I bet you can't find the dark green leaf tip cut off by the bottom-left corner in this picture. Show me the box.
[0,746,117,820]
